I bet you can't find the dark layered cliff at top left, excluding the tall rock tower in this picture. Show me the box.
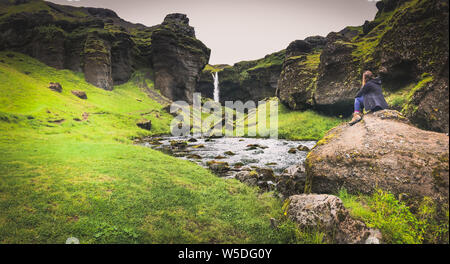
[0,0,144,90]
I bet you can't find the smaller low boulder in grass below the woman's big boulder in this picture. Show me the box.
[287,194,381,244]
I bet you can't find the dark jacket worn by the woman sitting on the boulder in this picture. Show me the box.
[356,78,389,111]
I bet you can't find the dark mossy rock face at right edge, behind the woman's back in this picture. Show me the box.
[372,0,449,133]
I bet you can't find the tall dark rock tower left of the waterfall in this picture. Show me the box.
[151,14,211,103]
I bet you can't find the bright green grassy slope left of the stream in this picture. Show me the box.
[0,52,317,243]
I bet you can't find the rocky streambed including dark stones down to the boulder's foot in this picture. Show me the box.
[141,137,316,195]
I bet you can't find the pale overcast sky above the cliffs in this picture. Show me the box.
[47,0,377,64]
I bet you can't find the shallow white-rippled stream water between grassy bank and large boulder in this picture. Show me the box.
[142,137,316,182]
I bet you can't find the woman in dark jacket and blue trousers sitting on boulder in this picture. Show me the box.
[349,71,389,125]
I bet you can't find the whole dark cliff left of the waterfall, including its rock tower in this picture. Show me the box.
[0,0,209,100]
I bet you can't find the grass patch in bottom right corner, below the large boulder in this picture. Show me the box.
[338,189,449,244]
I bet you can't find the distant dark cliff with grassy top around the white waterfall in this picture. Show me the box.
[197,50,285,103]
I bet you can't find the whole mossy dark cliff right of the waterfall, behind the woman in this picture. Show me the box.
[278,0,449,132]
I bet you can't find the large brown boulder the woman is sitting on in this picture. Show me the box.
[305,110,449,205]
